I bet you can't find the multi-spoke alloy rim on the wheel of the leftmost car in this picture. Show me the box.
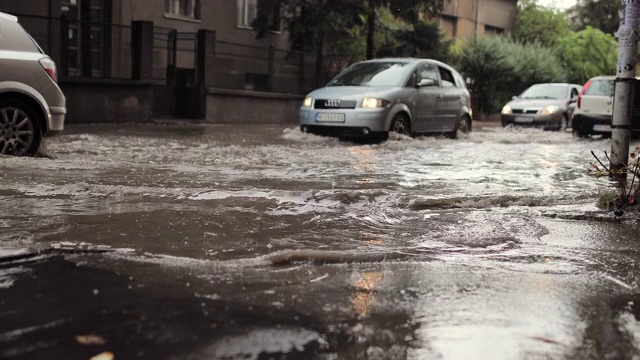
[0,107,35,155]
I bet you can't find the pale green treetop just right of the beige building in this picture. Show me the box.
[513,1,571,46]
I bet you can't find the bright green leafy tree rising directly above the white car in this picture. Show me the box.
[556,26,618,84]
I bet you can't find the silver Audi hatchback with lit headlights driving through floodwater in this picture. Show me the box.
[299,58,472,139]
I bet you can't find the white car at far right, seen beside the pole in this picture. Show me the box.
[571,76,616,138]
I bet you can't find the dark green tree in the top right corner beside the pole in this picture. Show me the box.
[575,0,622,35]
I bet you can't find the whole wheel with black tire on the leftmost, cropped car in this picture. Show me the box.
[0,99,42,156]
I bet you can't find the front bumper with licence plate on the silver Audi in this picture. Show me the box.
[298,108,390,135]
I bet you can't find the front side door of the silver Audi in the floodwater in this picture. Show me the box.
[413,62,441,132]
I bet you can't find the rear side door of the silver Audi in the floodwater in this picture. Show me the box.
[436,66,463,131]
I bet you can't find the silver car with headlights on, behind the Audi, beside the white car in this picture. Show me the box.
[501,83,582,130]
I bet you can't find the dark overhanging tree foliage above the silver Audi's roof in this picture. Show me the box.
[252,0,445,58]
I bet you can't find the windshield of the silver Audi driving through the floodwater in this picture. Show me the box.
[327,62,409,86]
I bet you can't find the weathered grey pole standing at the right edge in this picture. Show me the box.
[610,0,640,176]
